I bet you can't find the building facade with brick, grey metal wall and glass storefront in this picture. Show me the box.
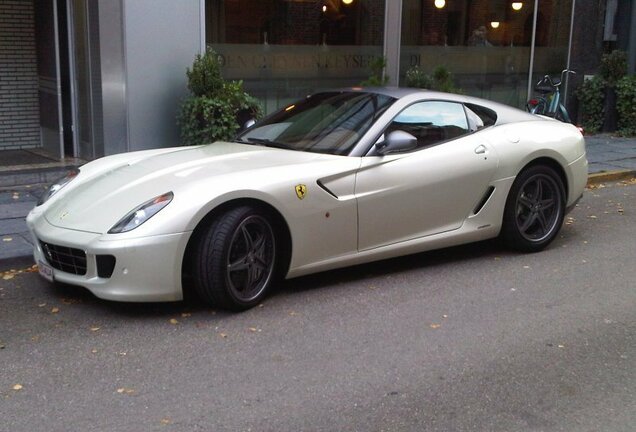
[0,0,636,159]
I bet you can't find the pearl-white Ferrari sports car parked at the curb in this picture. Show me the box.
[27,88,587,310]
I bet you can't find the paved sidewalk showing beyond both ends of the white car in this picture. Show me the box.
[0,135,636,271]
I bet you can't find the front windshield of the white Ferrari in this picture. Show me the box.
[237,91,395,155]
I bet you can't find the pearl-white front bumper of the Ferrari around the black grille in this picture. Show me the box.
[27,213,191,302]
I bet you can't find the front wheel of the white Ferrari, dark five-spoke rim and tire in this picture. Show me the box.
[194,206,277,311]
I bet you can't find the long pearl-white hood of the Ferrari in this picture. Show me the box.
[44,142,343,233]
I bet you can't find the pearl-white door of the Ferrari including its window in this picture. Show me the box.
[355,101,497,251]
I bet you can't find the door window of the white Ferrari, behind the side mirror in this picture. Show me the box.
[385,101,471,148]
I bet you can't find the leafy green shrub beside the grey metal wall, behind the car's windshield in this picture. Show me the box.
[177,49,262,145]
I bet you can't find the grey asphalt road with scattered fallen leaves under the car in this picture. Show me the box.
[0,181,636,432]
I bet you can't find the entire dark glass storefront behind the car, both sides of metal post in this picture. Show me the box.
[206,0,572,112]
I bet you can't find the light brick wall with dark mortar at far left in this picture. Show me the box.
[0,0,40,150]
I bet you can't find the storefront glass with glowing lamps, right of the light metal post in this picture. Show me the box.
[400,0,572,107]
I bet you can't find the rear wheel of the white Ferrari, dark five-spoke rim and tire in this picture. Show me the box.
[501,165,566,252]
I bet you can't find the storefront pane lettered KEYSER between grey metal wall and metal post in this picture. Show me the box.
[206,0,385,112]
